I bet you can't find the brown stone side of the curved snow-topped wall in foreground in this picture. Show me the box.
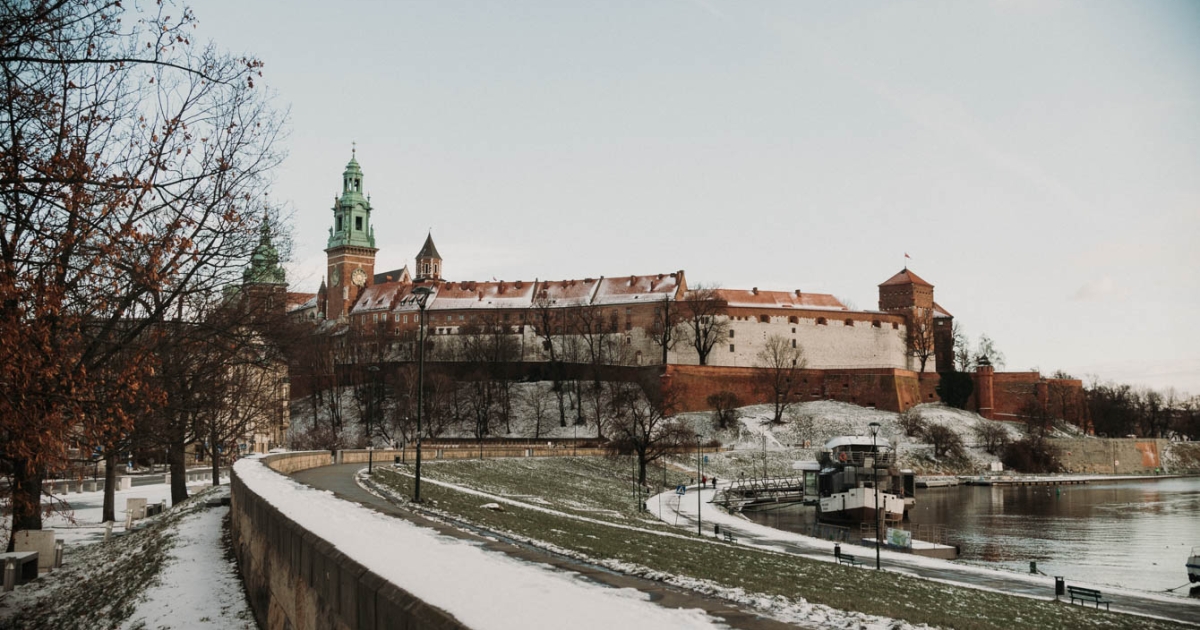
[230,451,466,630]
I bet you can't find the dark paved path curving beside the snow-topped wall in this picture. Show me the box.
[292,463,816,630]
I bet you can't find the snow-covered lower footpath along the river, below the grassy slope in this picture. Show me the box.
[667,488,1200,624]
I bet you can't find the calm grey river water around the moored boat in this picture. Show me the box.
[746,478,1200,596]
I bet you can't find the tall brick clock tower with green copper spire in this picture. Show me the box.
[325,152,379,319]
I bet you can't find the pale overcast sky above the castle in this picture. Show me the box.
[194,0,1200,394]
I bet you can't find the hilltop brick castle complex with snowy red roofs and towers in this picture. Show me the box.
[292,150,1080,415]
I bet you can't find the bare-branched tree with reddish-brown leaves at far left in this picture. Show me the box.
[0,0,280,544]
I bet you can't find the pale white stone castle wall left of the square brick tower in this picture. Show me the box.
[671,312,912,371]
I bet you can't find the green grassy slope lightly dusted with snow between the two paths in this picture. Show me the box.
[377,458,1177,630]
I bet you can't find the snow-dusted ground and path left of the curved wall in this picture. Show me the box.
[0,484,256,629]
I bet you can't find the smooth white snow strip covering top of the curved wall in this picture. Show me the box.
[234,460,722,630]
